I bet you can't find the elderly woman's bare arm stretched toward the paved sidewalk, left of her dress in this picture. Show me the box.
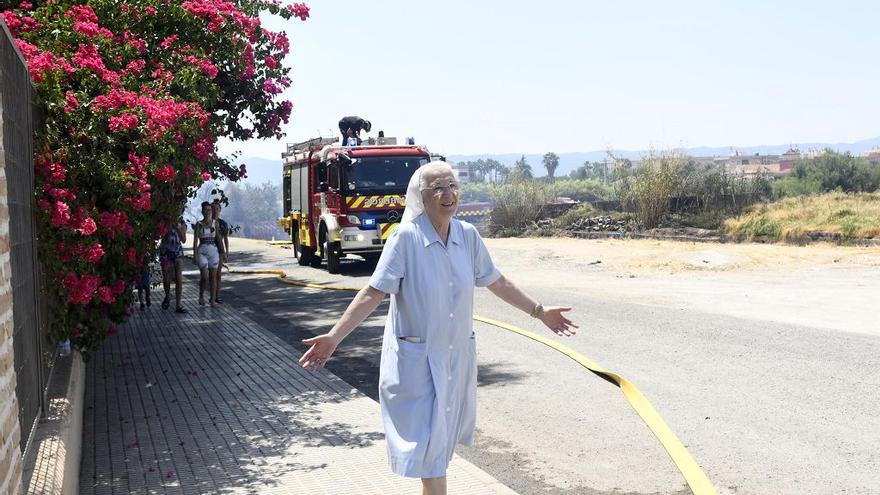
[299,285,385,371]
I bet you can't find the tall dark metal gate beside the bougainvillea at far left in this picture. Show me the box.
[0,20,49,451]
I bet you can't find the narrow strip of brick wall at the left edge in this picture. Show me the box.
[0,92,22,493]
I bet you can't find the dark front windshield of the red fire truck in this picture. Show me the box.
[342,156,429,194]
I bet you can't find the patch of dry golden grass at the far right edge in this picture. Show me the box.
[724,192,880,242]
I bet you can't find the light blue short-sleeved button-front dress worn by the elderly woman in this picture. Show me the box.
[370,214,501,478]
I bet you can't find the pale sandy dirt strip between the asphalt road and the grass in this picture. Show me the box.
[486,238,880,336]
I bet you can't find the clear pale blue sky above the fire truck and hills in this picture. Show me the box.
[215,0,880,159]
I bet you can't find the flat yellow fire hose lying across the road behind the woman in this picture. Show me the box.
[226,265,718,495]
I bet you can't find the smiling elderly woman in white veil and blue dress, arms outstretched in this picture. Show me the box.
[299,162,577,495]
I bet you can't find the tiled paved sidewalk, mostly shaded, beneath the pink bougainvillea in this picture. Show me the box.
[80,279,514,495]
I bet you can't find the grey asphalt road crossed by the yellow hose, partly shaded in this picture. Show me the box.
[208,241,880,494]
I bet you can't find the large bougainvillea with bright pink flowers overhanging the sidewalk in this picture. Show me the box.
[0,0,309,355]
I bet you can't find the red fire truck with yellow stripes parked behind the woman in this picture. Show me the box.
[280,138,431,273]
